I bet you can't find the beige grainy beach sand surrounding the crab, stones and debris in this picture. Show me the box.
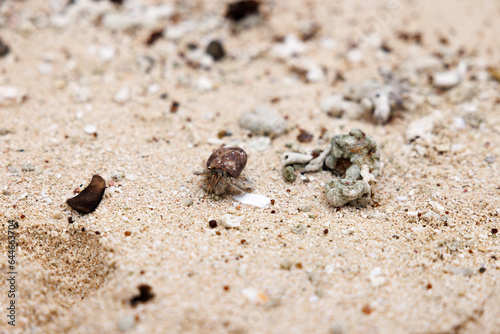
[0,0,500,333]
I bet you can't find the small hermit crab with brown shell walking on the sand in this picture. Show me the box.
[194,147,253,195]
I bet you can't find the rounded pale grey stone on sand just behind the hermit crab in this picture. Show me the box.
[239,105,286,137]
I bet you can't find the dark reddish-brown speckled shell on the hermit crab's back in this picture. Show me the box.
[207,147,247,178]
